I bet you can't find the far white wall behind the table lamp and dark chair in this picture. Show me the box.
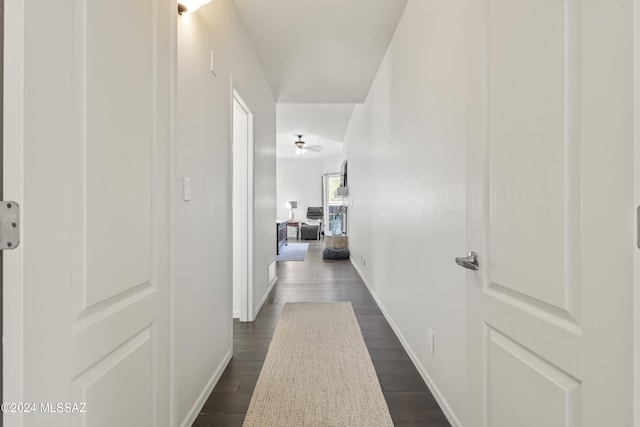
[276,159,324,237]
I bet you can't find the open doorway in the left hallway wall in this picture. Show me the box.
[231,90,255,322]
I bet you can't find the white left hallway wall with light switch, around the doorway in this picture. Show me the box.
[172,0,276,425]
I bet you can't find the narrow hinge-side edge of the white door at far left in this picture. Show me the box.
[3,1,24,427]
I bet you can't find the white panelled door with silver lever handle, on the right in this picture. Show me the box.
[465,0,633,427]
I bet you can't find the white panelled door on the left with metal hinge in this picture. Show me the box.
[4,0,176,427]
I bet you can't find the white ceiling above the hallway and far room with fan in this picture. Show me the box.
[235,0,407,158]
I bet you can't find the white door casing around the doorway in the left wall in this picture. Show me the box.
[231,85,255,322]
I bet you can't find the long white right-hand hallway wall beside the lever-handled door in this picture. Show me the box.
[345,0,465,422]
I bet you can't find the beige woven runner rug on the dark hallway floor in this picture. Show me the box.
[244,302,393,427]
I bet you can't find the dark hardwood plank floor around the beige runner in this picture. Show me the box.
[193,240,450,427]
